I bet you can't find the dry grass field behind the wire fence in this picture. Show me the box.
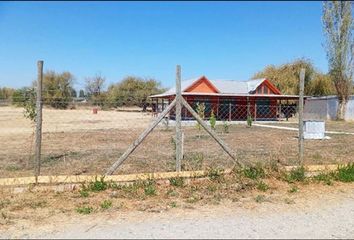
[0,107,354,177]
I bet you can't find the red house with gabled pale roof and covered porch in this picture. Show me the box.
[150,76,298,121]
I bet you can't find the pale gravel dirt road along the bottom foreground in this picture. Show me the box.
[4,188,354,238]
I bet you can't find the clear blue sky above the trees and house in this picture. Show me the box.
[0,1,327,90]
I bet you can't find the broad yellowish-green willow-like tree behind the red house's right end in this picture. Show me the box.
[252,59,316,94]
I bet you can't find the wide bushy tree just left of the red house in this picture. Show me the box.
[108,76,163,111]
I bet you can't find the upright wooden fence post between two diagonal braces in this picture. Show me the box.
[176,65,182,172]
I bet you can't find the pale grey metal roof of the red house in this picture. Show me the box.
[151,76,276,97]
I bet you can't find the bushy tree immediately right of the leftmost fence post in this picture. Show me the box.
[42,71,74,109]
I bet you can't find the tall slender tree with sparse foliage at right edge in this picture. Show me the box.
[322,1,354,120]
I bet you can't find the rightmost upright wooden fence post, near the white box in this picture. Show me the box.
[299,68,305,165]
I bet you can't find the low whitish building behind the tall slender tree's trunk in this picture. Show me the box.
[304,96,354,121]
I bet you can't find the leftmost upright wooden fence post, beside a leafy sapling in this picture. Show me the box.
[34,61,43,183]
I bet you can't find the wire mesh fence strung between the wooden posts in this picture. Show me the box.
[0,95,354,177]
